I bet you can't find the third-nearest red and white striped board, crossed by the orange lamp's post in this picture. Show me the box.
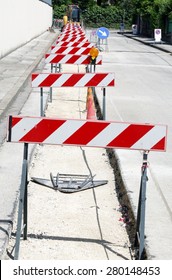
[45,54,102,65]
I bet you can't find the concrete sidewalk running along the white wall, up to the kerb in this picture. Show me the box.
[0,31,59,143]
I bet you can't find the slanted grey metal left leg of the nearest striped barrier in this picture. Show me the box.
[14,146,27,260]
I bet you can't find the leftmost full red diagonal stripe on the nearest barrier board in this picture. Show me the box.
[20,119,65,143]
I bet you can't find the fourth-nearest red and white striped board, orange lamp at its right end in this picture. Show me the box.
[51,45,91,55]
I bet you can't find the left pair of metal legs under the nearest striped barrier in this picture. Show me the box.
[14,143,28,260]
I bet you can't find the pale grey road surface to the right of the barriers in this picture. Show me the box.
[96,32,172,259]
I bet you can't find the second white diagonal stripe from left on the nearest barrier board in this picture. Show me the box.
[43,120,86,144]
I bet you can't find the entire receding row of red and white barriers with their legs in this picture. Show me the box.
[7,24,167,259]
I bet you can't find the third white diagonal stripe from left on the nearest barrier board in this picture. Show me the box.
[87,123,130,147]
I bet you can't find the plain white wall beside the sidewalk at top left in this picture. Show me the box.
[0,0,53,57]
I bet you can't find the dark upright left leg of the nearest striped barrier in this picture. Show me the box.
[23,143,28,240]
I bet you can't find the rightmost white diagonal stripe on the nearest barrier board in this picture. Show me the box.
[131,125,166,150]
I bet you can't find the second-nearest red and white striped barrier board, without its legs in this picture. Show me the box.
[32,73,115,88]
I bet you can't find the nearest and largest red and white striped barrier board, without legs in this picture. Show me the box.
[8,116,167,151]
